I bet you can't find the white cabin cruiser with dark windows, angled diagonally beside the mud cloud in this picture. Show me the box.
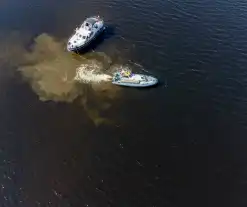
[67,16,105,52]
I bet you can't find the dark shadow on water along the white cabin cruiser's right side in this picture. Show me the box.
[75,25,115,55]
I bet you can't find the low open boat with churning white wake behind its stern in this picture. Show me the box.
[112,70,158,87]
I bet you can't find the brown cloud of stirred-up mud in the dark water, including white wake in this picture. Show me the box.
[1,34,127,125]
